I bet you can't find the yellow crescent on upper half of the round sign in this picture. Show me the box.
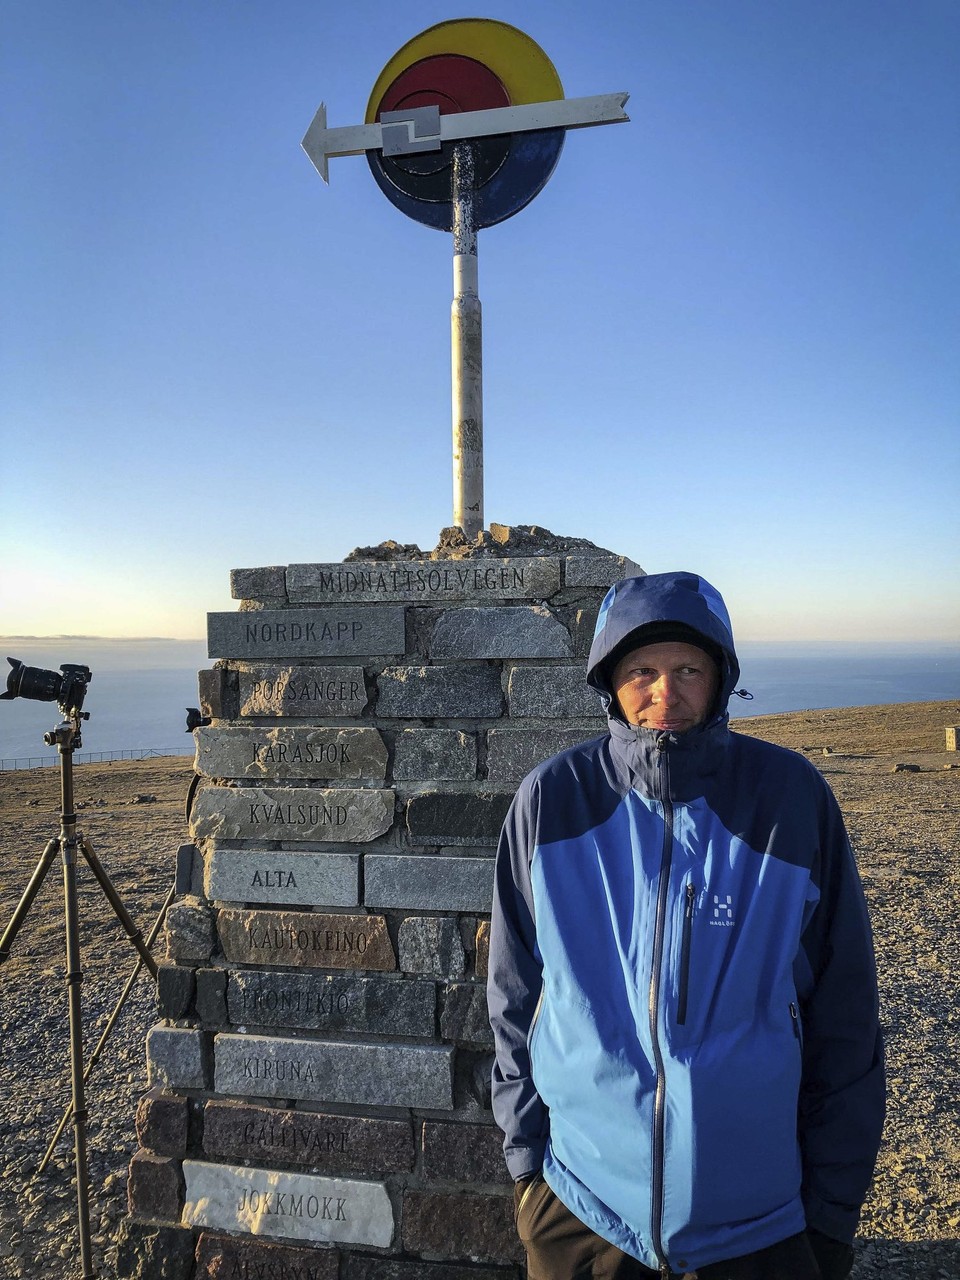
[364,18,563,124]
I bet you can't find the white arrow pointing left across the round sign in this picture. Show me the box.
[301,93,630,182]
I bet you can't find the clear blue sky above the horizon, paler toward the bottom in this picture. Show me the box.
[0,0,960,640]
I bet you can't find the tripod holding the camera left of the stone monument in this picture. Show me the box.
[0,704,163,1280]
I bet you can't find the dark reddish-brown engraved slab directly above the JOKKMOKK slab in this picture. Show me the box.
[204,1098,414,1174]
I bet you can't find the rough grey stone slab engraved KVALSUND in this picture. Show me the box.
[191,787,394,844]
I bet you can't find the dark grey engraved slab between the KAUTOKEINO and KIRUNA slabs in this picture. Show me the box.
[227,969,435,1039]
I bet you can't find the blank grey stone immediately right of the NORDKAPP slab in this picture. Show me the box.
[430,604,573,658]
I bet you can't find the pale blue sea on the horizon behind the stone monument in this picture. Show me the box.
[0,636,960,769]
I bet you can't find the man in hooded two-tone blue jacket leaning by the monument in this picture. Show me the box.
[488,573,883,1280]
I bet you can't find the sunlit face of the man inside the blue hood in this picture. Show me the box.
[611,640,719,733]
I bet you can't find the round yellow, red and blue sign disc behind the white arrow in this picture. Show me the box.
[365,18,564,230]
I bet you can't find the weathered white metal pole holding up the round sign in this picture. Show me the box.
[451,142,484,539]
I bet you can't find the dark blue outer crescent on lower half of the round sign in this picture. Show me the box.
[366,129,567,232]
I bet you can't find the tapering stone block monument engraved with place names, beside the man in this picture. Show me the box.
[118,525,641,1280]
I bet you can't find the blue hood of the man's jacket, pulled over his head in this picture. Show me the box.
[586,572,740,721]
